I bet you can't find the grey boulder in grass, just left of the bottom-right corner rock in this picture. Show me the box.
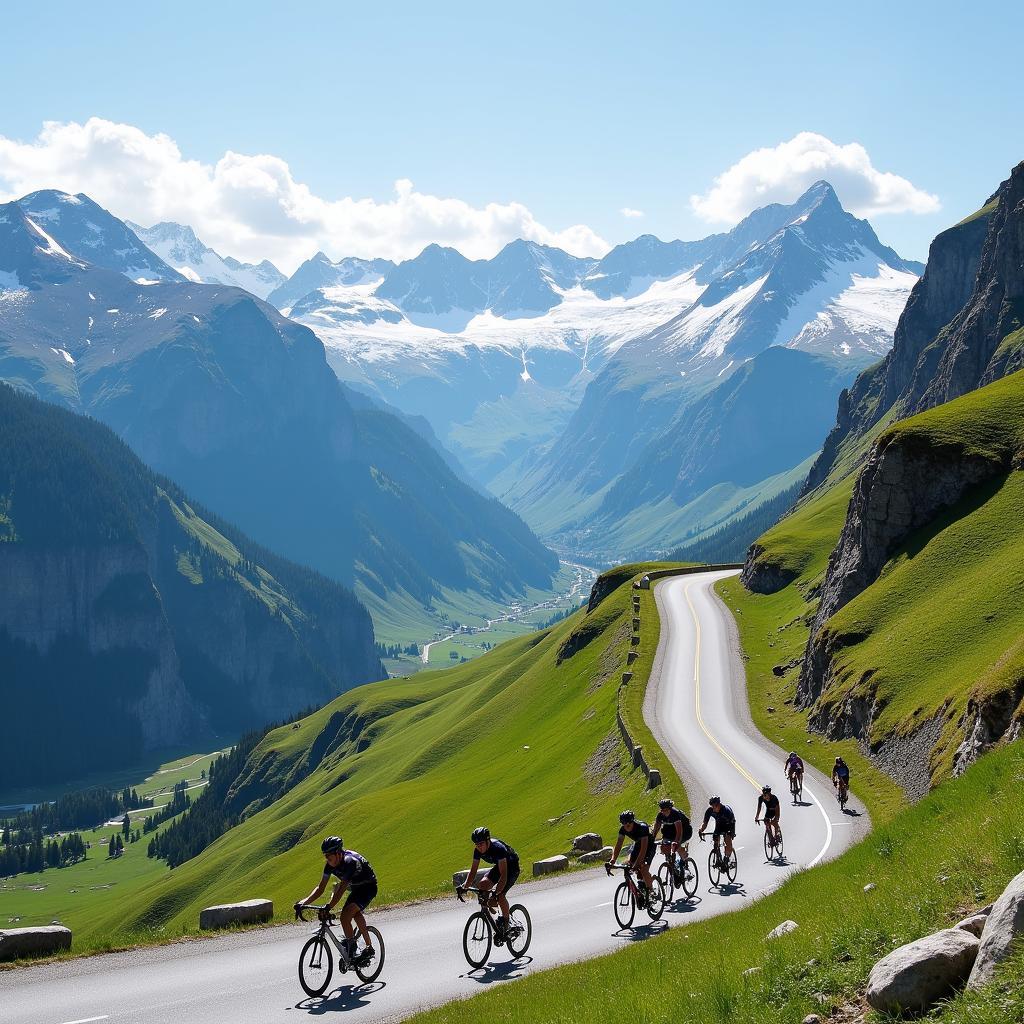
[867,928,979,1015]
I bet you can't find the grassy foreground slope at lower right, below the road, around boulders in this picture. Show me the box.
[414,743,1024,1024]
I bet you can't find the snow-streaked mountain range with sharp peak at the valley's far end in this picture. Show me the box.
[291,182,921,517]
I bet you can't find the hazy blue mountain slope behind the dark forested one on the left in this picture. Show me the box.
[0,194,557,634]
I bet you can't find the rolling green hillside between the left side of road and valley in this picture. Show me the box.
[74,565,681,949]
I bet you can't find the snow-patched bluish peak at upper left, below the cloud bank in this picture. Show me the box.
[17,188,184,285]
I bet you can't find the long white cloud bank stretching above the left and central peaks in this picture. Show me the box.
[0,118,609,272]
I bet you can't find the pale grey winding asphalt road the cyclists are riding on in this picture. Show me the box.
[0,572,867,1024]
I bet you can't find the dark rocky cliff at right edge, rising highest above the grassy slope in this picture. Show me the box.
[808,164,1024,489]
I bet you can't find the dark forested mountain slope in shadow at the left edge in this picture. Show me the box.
[0,384,384,782]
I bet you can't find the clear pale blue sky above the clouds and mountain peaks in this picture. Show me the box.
[0,0,1024,262]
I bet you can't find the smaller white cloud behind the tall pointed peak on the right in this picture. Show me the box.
[690,131,939,224]
